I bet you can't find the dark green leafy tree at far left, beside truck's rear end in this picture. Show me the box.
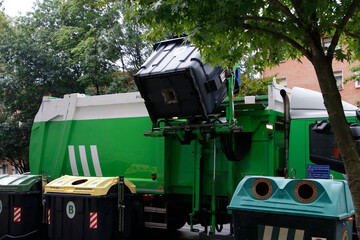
[0,4,84,171]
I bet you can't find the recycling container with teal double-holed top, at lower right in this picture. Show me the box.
[228,177,355,240]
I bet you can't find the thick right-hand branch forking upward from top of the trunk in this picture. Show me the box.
[327,0,360,59]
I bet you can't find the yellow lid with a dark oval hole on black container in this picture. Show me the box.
[45,175,135,196]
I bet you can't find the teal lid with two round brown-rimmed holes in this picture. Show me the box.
[228,176,355,219]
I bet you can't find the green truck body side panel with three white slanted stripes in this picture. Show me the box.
[30,117,164,191]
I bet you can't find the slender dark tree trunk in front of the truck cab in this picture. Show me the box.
[311,36,360,236]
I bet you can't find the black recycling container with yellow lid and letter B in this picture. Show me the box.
[45,176,135,240]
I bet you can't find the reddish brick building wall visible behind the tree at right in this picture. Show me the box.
[263,57,360,105]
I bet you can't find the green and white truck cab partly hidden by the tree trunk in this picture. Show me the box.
[289,87,360,179]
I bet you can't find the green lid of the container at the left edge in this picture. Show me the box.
[0,174,41,192]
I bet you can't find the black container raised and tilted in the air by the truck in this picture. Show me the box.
[135,38,227,122]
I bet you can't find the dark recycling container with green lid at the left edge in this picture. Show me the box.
[0,175,44,240]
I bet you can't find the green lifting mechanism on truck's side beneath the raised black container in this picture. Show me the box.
[144,65,242,239]
